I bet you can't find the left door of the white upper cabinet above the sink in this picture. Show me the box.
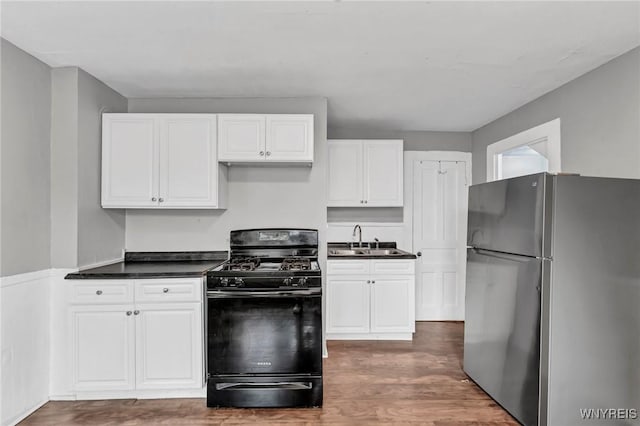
[328,140,364,207]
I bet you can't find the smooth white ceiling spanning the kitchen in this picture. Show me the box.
[1,1,640,131]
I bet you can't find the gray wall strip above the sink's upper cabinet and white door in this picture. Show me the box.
[327,127,471,152]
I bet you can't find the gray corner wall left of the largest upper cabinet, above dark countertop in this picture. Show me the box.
[51,67,127,268]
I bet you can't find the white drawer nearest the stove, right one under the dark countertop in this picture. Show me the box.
[135,278,202,303]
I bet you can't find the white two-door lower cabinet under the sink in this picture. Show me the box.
[326,259,415,340]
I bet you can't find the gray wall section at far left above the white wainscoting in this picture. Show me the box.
[0,39,51,276]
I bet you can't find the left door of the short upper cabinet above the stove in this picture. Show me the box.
[218,114,266,161]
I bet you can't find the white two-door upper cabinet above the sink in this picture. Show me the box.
[328,140,403,207]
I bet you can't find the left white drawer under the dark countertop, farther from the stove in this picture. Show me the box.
[70,280,133,304]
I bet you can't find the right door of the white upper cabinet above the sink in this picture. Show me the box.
[363,140,403,207]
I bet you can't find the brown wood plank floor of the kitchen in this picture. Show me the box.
[20,322,518,426]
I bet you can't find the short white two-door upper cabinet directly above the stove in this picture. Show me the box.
[218,114,313,163]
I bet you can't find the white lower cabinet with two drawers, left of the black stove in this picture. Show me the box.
[69,278,204,399]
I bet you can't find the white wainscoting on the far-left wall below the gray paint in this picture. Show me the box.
[0,269,51,425]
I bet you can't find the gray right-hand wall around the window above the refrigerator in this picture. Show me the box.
[473,48,640,183]
